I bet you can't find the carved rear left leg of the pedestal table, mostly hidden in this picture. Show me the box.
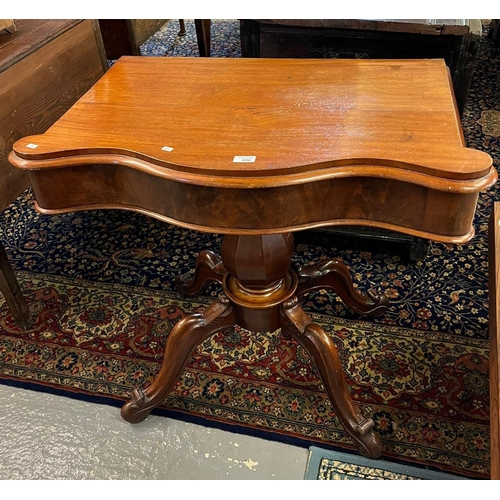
[175,250,225,295]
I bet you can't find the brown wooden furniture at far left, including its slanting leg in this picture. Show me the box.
[0,19,108,328]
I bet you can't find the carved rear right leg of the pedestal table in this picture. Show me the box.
[297,259,389,316]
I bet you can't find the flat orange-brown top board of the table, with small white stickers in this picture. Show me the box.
[12,57,491,178]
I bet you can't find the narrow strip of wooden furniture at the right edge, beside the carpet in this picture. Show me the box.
[489,202,500,479]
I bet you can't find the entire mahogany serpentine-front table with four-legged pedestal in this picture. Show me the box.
[10,57,497,457]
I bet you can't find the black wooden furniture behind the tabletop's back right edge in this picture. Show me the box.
[240,19,482,114]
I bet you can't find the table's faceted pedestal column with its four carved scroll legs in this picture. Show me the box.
[121,233,389,458]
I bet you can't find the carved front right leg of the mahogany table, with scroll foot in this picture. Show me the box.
[281,297,382,458]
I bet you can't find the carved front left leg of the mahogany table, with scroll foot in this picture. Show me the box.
[121,295,236,424]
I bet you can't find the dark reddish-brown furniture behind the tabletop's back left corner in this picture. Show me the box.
[99,19,169,59]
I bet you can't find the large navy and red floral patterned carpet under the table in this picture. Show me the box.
[0,20,500,478]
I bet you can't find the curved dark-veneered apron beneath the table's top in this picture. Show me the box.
[28,165,478,243]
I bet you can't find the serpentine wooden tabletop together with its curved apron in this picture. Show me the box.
[7,57,496,242]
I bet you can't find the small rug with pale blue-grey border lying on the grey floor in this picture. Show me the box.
[304,446,463,481]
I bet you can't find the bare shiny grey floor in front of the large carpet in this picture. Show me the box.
[0,385,308,480]
